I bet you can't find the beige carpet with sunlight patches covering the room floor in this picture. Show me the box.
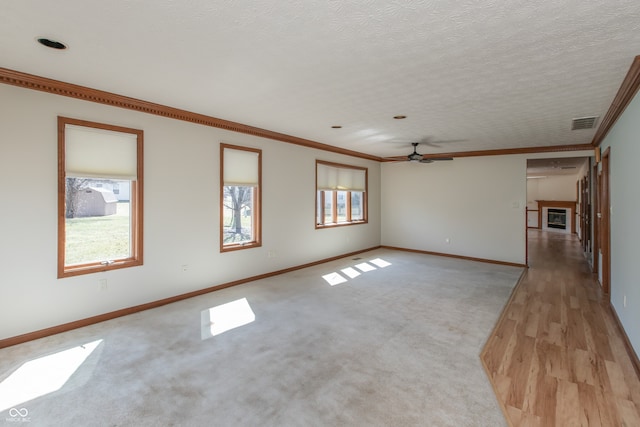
[0,249,522,427]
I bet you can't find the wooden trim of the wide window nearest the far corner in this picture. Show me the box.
[315,160,369,229]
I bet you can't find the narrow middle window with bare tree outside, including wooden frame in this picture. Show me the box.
[220,144,262,252]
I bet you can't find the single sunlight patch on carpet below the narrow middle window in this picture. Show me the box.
[200,298,256,340]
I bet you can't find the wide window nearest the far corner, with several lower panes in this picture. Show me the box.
[316,160,368,228]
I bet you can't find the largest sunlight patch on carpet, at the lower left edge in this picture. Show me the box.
[0,340,102,412]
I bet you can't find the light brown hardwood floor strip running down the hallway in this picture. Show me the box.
[481,230,640,427]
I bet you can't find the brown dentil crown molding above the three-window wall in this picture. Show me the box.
[0,68,381,161]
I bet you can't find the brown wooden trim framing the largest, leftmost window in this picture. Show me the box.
[58,116,144,279]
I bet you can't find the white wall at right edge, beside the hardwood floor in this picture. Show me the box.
[601,88,640,354]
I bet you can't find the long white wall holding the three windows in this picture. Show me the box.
[0,85,380,339]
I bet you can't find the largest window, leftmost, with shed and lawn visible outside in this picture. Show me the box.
[58,117,143,278]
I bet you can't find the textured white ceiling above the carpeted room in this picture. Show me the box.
[0,0,640,156]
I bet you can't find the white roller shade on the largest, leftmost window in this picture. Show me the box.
[64,124,138,181]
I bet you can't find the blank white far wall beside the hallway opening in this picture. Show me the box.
[382,155,526,264]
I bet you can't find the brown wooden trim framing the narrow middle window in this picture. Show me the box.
[220,143,262,252]
